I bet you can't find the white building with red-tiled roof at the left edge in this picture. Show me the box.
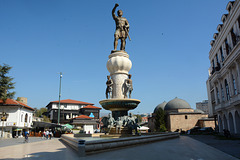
[0,99,34,138]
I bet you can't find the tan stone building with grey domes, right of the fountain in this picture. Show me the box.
[148,97,215,132]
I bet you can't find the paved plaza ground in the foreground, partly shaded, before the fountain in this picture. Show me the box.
[0,136,237,160]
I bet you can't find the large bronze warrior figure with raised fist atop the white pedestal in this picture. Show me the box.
[112,3,131,51]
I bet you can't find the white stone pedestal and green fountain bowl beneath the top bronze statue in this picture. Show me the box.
[99,51,140,136]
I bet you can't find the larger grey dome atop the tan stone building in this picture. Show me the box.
[164,97,191,110]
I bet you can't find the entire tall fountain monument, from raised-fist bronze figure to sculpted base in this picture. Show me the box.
[99,4,141,136]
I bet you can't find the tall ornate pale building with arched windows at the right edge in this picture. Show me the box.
[207,0,240,134]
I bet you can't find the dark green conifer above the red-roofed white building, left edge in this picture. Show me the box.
[0,64,15,103]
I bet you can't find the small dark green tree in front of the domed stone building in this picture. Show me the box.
[155,108,167,132]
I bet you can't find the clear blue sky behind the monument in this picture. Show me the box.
[0,0,232,113]
